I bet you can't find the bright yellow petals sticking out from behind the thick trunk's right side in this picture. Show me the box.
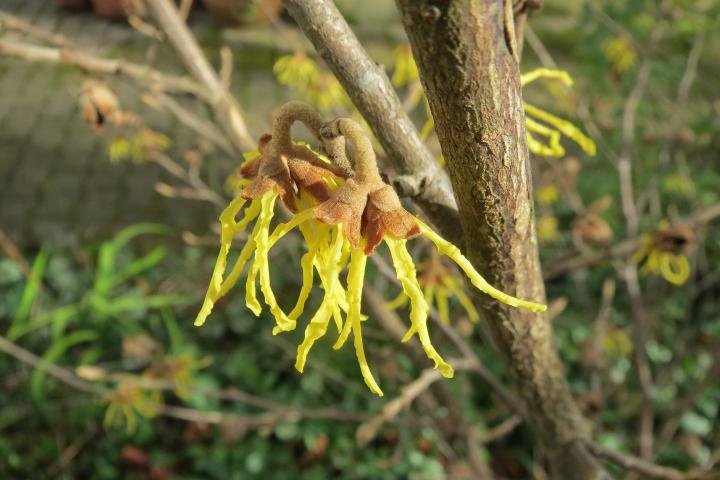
[520,68,596,157]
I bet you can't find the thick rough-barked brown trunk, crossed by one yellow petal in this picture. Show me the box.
[398,0,606,479]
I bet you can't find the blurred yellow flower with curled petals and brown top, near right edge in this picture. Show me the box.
[632,225,695,285]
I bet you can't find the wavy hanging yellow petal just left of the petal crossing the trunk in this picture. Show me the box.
[385,236,454,378]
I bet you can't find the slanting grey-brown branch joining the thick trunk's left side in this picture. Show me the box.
[283,0,460,246]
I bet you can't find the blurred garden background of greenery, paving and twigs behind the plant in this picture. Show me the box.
[0,0,720,480]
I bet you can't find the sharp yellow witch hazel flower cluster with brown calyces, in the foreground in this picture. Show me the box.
[195,102,545,395]
